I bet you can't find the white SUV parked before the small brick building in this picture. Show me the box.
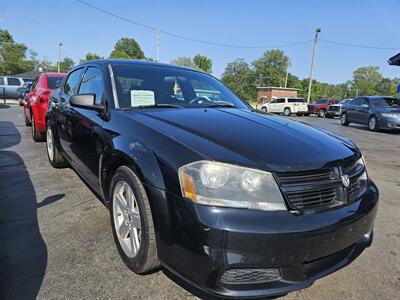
[261,97,308,116]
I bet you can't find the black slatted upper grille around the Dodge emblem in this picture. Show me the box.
[277,160,366,210]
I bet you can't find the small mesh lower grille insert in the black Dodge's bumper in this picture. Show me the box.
[221,268,281,284]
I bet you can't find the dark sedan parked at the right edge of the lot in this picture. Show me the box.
[340,96,400,131]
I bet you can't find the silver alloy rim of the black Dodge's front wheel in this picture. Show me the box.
[112,181,141,258]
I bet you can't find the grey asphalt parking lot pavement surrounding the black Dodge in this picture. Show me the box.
[0,101,400,299]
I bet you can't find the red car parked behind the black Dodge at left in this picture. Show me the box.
[24,73,65,142]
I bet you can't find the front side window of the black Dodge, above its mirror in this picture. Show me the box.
[79,67,105,104]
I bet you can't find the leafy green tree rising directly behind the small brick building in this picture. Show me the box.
[252,50,289,86]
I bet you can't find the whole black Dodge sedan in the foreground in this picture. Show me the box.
[46,60,378,298]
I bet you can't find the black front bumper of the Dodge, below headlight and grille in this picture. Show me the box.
[153,182,378,298]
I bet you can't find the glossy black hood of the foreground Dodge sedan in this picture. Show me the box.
[128,108,358,171]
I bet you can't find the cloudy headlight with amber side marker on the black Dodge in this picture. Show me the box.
[178,161,287,211]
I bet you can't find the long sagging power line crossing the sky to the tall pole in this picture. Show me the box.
[76,0,312,49]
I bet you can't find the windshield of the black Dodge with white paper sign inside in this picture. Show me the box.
[113,64,248,108]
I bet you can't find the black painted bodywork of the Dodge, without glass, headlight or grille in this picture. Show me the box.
[47,60,378,297]
